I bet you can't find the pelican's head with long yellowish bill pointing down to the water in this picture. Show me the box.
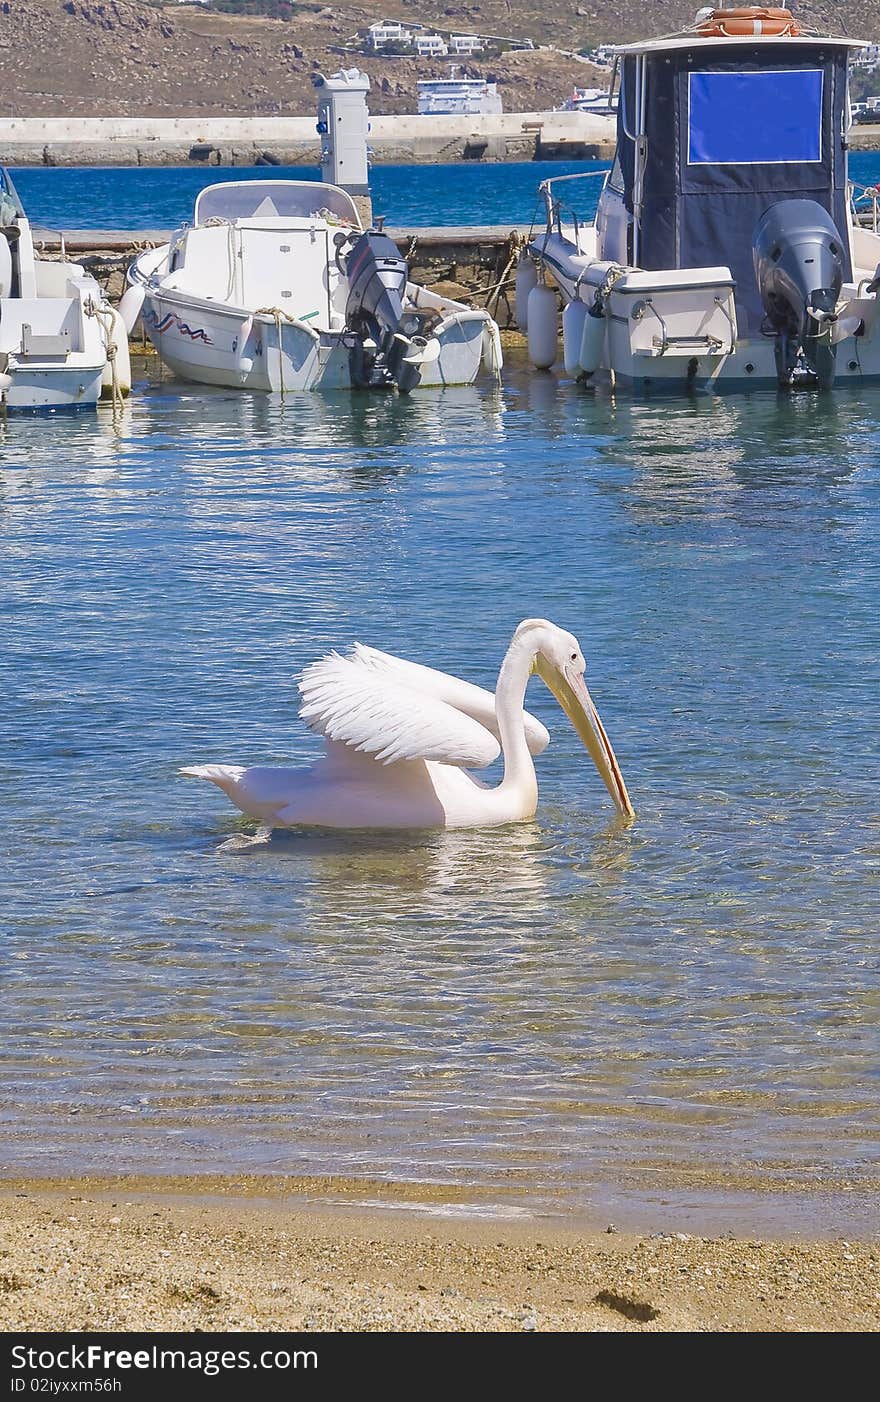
[514,618,635,817]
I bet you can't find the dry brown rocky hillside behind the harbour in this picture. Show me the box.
[0,0,880,116]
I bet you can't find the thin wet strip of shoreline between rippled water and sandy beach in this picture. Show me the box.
[0,1161,880,1241]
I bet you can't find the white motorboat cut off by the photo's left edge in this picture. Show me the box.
[0,167,132,411]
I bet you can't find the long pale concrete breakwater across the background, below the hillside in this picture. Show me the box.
[0,112,614,165]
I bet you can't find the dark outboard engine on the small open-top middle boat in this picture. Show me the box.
[336,229,427,394]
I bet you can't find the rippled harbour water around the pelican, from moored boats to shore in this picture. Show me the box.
[0,350,880,1202]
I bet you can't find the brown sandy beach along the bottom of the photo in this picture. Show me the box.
[0,1178,880,1332]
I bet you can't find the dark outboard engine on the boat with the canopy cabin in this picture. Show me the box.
[751,199,844,388]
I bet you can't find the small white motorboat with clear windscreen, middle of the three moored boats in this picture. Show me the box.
[127,181,502,394]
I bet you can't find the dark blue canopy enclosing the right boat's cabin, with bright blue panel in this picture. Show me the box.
[618,39,852,332]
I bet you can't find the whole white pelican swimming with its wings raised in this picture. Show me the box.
[181,618,633,829]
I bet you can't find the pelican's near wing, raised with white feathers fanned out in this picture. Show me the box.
[300,652,500,768]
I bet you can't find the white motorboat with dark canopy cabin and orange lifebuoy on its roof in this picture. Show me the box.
[517,8,880,391]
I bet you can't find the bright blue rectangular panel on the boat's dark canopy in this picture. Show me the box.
[688,69,823,165]
